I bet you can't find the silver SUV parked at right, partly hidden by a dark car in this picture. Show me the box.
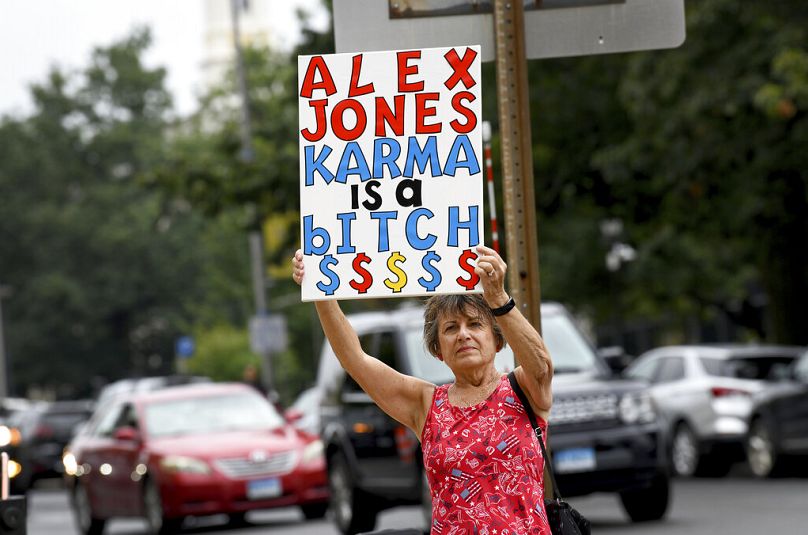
[624,345,805,476]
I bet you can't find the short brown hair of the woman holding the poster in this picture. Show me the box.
[424,294,505,357]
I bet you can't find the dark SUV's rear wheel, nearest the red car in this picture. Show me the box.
[328,455,378,535]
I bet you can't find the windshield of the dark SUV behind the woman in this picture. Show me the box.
[405,314,597,384]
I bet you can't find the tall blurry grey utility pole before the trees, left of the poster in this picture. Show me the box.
[230,0,275,392]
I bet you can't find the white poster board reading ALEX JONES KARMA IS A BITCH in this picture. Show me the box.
[298,46,484,301]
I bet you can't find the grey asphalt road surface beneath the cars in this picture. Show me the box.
[28,476,808,535]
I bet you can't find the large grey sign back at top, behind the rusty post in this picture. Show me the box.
[334,0,685,61]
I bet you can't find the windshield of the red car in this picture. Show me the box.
[145,393,283,437]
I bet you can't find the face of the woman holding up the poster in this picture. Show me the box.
[438,308,497,371]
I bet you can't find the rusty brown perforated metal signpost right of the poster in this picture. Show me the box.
[494,0,541,332]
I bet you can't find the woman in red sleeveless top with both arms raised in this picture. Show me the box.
[292,246,553,535]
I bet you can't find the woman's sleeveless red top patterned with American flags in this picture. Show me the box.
[421,375,550,535]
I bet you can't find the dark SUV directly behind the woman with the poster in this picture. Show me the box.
[318,303,670,534]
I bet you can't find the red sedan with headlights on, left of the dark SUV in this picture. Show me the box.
[63,384,329,535]
